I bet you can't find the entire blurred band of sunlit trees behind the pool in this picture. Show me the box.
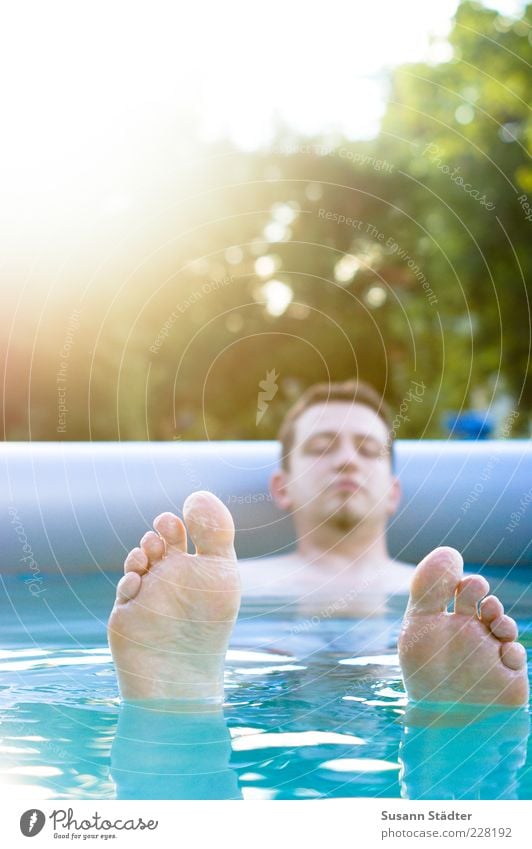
[4,3,532,439]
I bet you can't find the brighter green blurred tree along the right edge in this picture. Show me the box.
[379,2,532,424]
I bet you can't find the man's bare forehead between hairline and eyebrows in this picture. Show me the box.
[295,401,388,445]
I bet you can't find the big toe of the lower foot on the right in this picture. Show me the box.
[409,546,464,613]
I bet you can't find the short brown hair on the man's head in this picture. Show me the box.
[278,380,393,471]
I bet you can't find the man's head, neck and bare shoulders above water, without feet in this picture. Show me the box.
[237,382,413,615]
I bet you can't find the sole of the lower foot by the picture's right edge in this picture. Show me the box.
[399,548,528,706]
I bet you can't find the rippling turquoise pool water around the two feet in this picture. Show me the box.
[0,574,532,799]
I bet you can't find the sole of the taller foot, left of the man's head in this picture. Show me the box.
[108,492,240,702]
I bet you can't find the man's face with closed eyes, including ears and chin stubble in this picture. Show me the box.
[278,401,399,531]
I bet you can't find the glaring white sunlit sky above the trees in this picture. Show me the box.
[0,0,520,234]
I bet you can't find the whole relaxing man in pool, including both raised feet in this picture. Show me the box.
[109,383,528,706]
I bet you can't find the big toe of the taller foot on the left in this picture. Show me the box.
[183,491,235,559]
